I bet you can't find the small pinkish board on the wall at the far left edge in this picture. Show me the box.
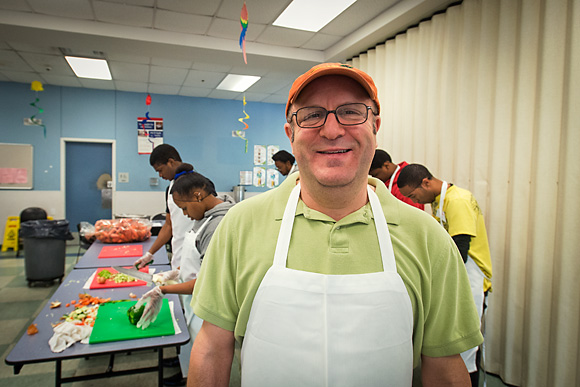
[0,143,34,189]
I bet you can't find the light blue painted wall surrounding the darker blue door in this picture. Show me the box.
[0,82,291,192]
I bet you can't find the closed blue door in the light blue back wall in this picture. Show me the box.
[66,142,112,227]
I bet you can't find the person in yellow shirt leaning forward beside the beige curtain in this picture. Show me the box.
[397,164,491,386]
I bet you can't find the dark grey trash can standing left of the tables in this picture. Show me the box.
[20,220,73,287]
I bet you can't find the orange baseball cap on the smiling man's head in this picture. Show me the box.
[286,63,381,117]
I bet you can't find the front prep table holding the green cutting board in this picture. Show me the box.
[5,265,190,386]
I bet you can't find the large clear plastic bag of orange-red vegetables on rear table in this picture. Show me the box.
[95,218,151,243]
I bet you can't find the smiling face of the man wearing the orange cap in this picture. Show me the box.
[284,75,380,188]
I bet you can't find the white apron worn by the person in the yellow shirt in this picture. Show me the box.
[436,181,485,373]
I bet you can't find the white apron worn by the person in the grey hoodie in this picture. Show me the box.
[179,216,212,376]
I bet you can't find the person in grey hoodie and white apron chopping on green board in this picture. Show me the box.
[137,170,234,385]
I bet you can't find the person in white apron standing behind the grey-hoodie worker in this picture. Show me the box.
[134,144,193,269]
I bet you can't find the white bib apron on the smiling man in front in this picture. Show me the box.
[241,184,413,387]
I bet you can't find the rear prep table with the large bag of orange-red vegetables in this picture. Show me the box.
[75,237,171,270]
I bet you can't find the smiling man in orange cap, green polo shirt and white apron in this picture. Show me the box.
[189,63,482,387]
